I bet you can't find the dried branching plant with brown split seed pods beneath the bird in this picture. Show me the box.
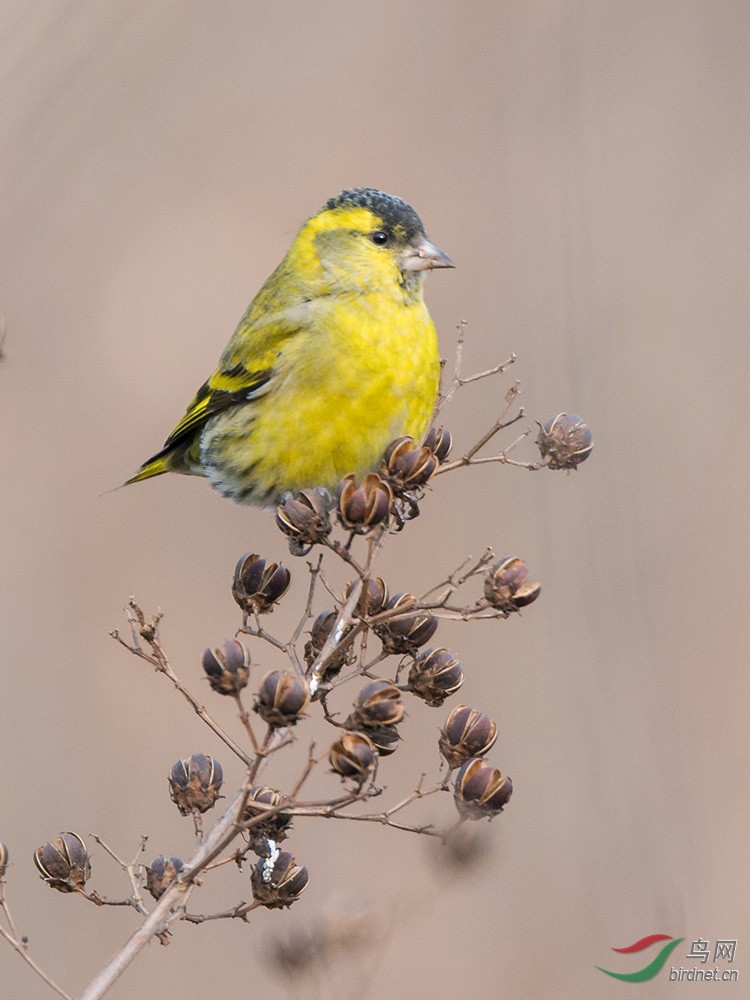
[0,324,592,1000]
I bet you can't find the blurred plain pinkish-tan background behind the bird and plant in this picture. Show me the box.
[0,0,750,1000]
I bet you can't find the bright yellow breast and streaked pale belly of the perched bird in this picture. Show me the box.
[200,292,440,503]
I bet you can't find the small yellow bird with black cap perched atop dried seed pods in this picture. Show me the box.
[125,188,455,506]
